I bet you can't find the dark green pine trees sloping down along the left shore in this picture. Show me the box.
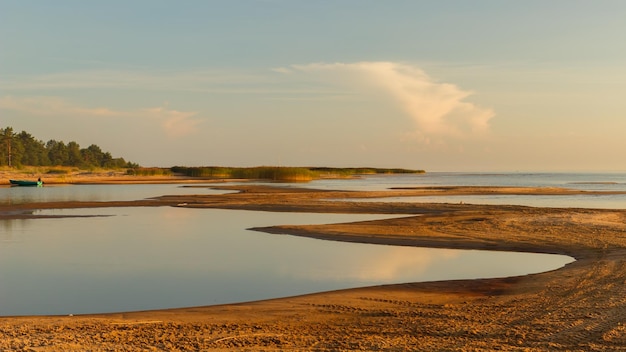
[0,127,139,168]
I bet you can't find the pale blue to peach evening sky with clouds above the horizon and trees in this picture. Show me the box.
[0,0,626,172]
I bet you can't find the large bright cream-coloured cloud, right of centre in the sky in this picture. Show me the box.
[286,62,495,137]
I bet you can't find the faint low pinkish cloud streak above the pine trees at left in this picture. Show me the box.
[0,96,200,138]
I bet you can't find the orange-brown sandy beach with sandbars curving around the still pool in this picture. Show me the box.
[0,175,626,351]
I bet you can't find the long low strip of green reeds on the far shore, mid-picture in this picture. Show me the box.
[171,166,424,182]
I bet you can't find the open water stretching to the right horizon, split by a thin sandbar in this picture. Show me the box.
[307,173,626,209]
